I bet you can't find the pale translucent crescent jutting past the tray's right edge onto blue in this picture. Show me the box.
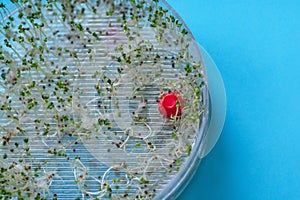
[199,45,226,158]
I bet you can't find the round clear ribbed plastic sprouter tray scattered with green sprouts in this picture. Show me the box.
[0,0,209,199]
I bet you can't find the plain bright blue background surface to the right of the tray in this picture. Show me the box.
[168,0,300,200]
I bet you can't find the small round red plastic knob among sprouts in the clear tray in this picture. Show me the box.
[158,92,184,119]
